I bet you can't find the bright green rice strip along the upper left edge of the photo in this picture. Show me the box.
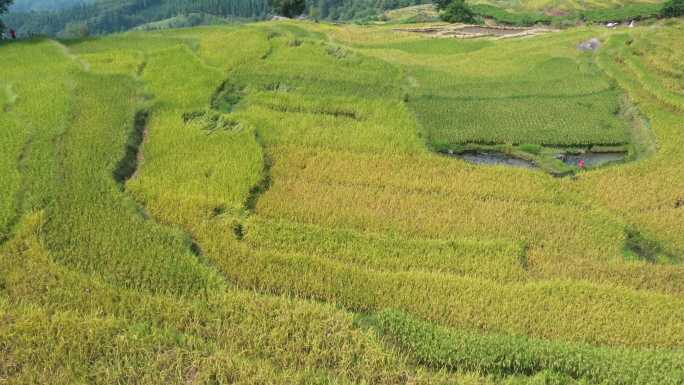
[0,40,74,242]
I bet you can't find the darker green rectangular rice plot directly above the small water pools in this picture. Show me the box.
[412,91,628,145]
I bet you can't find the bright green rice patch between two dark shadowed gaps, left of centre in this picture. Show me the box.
[123,46,262,220]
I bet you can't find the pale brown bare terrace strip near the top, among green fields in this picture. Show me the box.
[394,24,555,39]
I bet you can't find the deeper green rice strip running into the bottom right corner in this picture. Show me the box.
[375,310,684,385]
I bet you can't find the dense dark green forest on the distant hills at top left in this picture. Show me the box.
[4,0,426,35]
